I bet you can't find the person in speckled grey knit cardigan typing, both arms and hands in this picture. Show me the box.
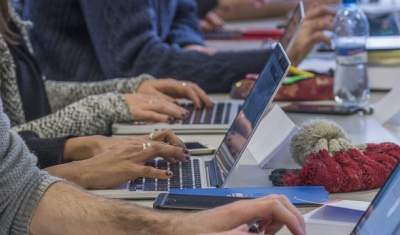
[0,0,212,138]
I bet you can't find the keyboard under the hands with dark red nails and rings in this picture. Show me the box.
[128,159,201,191]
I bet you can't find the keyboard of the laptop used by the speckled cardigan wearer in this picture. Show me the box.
[175,102,232,125]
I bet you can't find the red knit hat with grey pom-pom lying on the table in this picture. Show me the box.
[270,120,400,193]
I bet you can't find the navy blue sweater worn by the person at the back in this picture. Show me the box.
[24,0,270,93]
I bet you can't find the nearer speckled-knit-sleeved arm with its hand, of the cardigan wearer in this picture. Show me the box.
[13,92,189,138]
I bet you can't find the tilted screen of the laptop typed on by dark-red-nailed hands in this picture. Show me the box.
[213,43,290,187]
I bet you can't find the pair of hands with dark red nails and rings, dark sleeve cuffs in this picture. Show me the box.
[19,130,195,189]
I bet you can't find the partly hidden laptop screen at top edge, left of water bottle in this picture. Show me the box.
[279,1,304,53]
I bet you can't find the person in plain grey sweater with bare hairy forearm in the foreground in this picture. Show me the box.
[0,99,305,235]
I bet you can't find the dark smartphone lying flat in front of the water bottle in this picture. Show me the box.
[282,102,373,115]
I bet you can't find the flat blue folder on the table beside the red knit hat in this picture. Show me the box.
[169,186,330,205]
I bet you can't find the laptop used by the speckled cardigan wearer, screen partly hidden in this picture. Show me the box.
[112,1,304,135]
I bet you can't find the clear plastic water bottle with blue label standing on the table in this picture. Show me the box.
[333,0,370,106]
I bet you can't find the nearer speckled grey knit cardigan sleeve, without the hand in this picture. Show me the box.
[13,93,133,138]
